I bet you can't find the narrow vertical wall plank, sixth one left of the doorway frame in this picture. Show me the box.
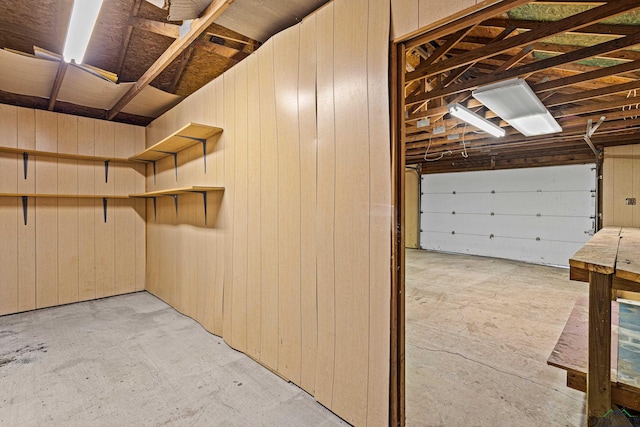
[258,38,280,370]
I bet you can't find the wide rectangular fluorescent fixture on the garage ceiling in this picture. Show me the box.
[472,78,562,136]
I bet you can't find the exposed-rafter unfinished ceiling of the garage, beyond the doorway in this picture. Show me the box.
[401,0,640,173]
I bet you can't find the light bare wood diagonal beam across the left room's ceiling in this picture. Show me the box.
[106,0,233,120]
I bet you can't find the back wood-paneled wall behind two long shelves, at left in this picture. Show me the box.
[0,105,146,315]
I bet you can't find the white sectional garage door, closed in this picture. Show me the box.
[420,164,596,266]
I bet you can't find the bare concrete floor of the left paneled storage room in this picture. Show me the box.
[0,292,347,426]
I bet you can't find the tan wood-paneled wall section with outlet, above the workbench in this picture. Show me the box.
[602,145,640,227]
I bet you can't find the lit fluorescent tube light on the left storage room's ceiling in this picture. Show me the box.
[62,0,102,64]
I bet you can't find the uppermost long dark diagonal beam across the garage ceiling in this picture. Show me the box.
[405,0,640,83]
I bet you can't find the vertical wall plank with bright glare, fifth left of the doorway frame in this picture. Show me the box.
[273,26,302,384]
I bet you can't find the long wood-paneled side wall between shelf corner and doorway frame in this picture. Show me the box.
[147,0,391,425]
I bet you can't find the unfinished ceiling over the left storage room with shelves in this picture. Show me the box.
[0,0,326,125]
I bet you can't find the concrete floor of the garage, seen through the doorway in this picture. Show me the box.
[406,250,588,427]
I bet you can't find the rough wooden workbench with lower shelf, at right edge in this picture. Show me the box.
[548,227,640,420]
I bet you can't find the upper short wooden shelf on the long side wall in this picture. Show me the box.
[129,123,222,162]
